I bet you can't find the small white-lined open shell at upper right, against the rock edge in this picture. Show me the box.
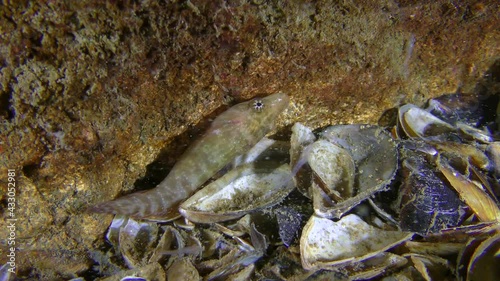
[398,104,456,139]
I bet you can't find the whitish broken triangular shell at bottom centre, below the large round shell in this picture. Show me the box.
[300,214,413,270]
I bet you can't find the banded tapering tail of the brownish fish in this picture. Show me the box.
[88,185,182,220]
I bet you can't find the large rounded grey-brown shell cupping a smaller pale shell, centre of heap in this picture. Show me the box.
[310,125,398,218]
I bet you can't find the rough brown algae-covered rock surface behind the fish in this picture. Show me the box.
[0,0,500,280]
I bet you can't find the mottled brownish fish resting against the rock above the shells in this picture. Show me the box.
[90,93,289,221]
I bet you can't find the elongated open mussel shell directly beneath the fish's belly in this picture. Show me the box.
[179,164,294,223]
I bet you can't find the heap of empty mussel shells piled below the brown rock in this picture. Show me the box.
[94,94,500,280]
